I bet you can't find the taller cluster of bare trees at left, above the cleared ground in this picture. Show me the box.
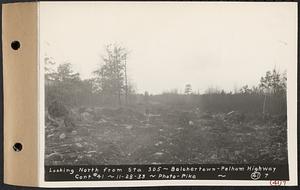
[44,45,135,105]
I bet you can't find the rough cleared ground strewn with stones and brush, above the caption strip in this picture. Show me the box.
[45,107,287,165]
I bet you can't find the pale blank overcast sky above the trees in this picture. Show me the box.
[40,2,297,94]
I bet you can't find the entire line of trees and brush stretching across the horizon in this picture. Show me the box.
[44,44,287,114]
